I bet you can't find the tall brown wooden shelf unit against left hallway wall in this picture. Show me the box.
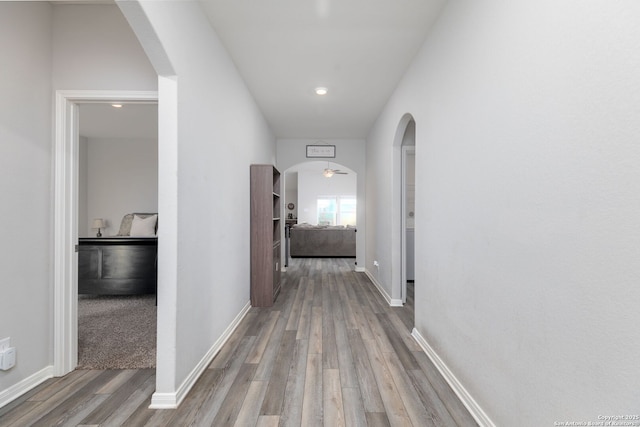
[251,165,282,307]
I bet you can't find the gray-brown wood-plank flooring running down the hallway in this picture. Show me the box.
[0,259,476,427]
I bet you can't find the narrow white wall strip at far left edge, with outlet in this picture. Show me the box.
[0,2,53,400]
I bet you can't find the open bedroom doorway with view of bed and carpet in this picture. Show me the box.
[76,102,158,369]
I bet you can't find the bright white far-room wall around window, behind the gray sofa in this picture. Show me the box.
[298,168,358,224]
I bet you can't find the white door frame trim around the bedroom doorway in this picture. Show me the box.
[53,90,158,376]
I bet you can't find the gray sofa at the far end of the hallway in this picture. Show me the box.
[289,224,356,258]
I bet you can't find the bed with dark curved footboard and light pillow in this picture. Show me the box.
[77,213,158,295]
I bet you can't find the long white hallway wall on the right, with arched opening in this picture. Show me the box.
[367,0,640,426]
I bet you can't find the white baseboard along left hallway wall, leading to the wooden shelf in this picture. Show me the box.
[149,302,251,409]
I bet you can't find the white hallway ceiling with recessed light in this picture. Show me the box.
[201,0,446,138]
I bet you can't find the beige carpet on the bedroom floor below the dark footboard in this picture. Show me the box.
[77,295,156,369]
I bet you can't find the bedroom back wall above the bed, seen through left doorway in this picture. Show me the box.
[79,138,158,237]
